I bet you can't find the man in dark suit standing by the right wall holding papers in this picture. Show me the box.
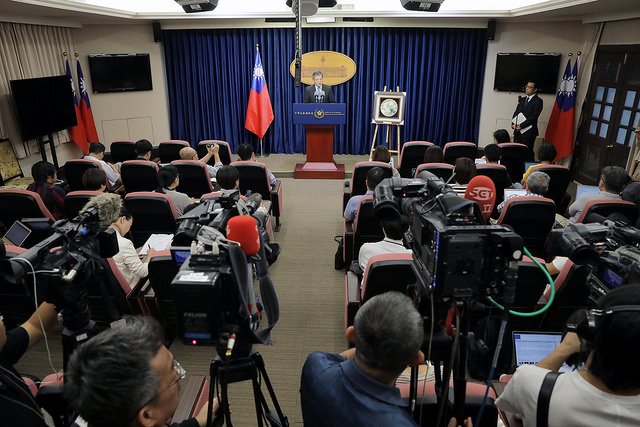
[511,80,542,162]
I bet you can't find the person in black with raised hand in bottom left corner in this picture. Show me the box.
[0,303,58,427]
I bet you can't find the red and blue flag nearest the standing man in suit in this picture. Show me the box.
[544,58,580,160]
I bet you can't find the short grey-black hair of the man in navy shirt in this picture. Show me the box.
[354,292,424,374]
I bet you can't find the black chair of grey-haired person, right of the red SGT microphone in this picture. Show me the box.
[498,197,556,258]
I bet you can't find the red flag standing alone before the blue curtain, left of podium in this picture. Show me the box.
[244,47,273,139]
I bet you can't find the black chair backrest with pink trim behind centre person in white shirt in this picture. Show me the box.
[361,254,416,303]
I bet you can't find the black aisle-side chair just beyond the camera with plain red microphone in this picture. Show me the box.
[231,161,282,231]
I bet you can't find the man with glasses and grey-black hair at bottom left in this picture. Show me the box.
[64,316,218,427]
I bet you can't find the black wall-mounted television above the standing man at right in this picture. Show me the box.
[493,53,560,93]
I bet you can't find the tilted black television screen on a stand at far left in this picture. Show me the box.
[10,74,78,141]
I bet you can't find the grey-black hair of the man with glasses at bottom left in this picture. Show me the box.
[63,316,163,427]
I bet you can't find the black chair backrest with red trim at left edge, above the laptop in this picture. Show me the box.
[0,190,56,228]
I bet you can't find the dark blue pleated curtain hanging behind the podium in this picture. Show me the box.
[162,28,487,154]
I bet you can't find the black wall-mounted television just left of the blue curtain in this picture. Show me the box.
[89,53,153,93]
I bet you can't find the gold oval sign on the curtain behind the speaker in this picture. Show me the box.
[289,50,356,86]
